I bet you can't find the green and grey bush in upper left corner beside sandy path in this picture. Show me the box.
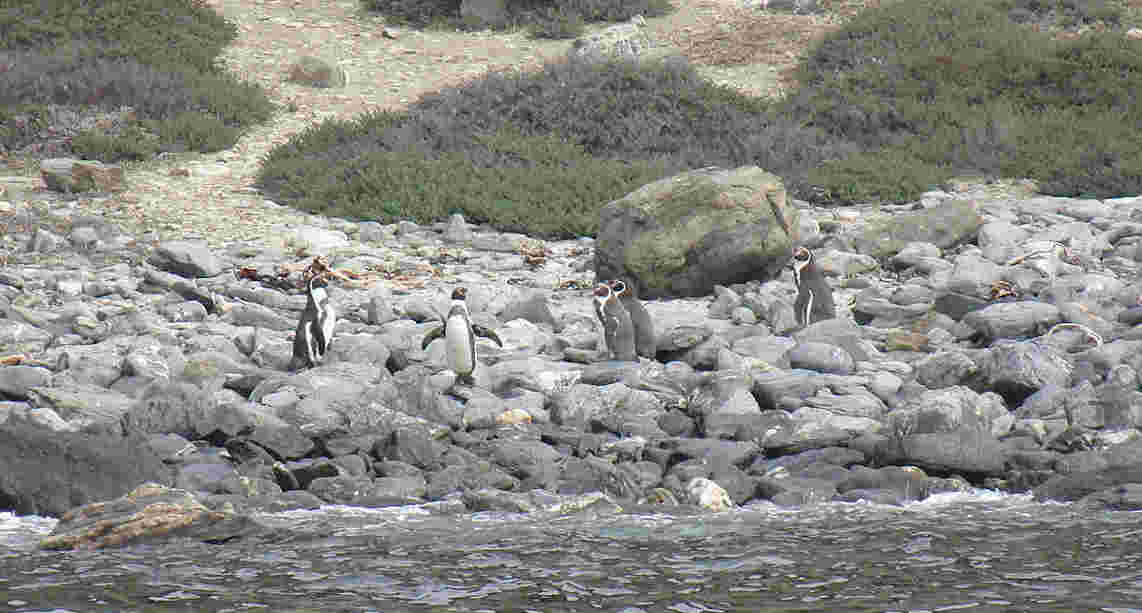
[0,0,273,161]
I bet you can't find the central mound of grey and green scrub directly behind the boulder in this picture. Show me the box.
[258,56,847,236]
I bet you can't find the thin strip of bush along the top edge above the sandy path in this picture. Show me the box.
[361,0,673,39]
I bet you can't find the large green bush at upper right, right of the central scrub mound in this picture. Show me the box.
[785,0,1142,202]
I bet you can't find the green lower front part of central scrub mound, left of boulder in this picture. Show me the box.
[258,113,668,237]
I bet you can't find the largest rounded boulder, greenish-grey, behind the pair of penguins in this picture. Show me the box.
[595,166,798,299]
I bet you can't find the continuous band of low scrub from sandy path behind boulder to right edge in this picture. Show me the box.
[258,0,1142,236]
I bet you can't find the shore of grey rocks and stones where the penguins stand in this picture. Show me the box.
[0,160,1142,547]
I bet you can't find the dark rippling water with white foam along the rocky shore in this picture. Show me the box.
[0,492,1142,613]
